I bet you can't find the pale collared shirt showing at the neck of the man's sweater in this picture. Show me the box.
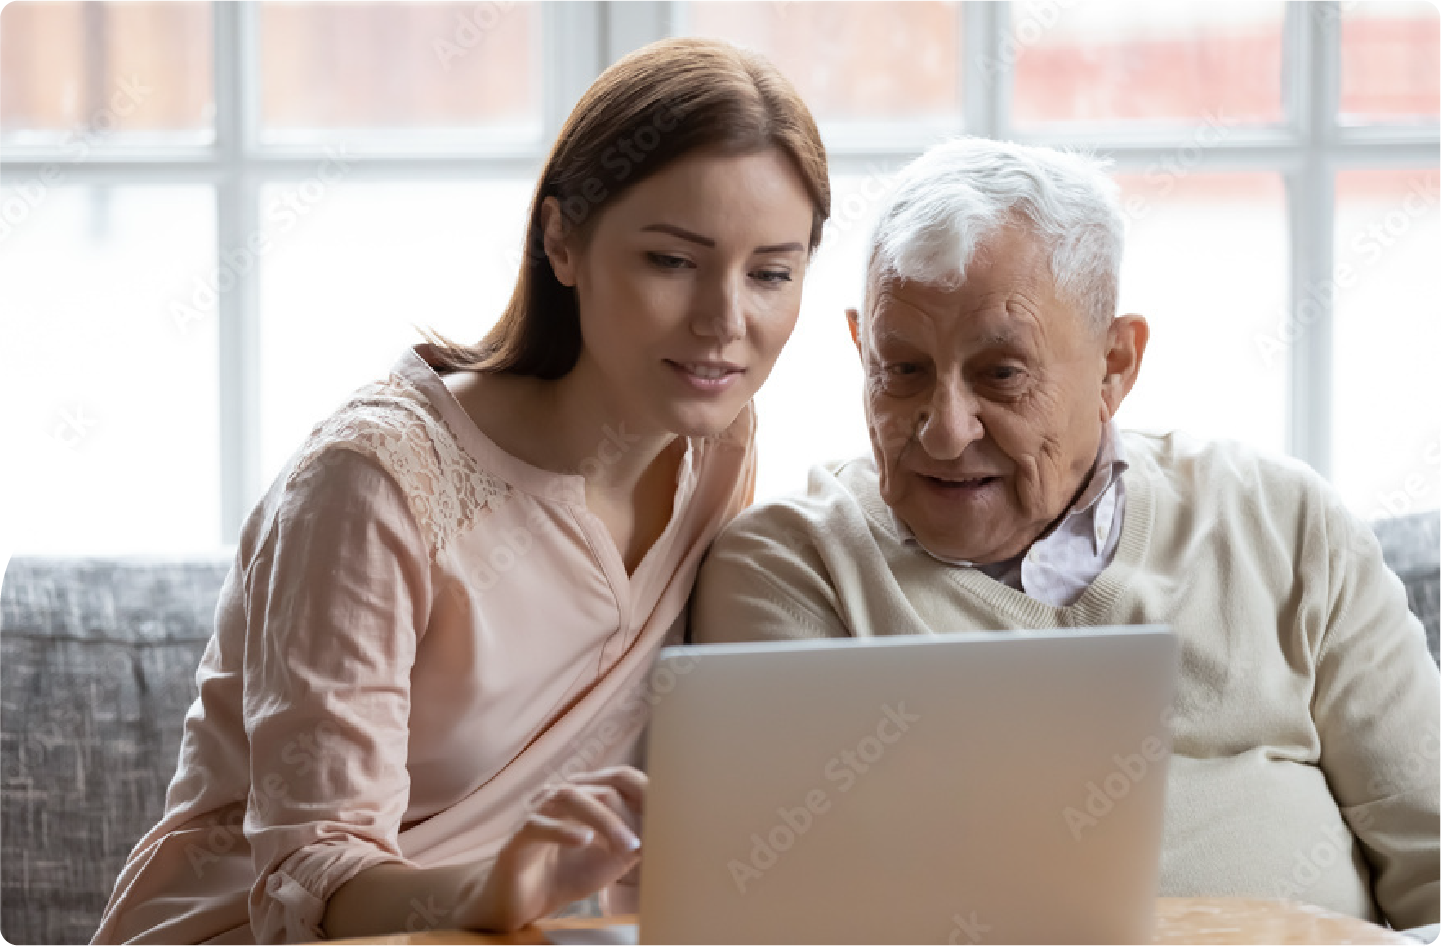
[892,421,1130,607]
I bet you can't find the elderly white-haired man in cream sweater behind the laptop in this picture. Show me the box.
[692,138,1441,927]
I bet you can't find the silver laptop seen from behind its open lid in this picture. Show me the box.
[640,627,1177,946]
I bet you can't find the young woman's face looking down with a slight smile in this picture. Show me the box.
[546,149,811,437]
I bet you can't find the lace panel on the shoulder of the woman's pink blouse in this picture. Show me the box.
[285,373,510,561]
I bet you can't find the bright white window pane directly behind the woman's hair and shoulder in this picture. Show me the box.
[261,177,535,485]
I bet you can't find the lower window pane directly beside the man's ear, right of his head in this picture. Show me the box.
[1117,169,1290,453]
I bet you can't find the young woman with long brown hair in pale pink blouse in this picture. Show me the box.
[94,40,830,946]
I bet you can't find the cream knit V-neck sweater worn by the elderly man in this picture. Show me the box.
[692,433,1441,927]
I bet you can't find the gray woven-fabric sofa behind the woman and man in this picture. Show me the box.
[0,513,1441,946]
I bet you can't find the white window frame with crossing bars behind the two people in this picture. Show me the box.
[0,0,1441,545]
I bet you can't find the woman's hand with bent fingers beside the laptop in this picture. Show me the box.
[465,766,647,930]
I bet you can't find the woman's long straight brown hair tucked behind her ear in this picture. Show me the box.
[424,39,830,381]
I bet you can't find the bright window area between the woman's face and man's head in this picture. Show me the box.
[755,170,889,499]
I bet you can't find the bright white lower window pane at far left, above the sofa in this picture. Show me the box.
[0,186,220,554]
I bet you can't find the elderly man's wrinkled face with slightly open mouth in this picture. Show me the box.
[857,226,1123,562]
